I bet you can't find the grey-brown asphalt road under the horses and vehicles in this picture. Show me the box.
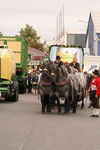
[0,94,100,150]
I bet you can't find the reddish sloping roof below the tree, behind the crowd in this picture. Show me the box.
[28,47,47,60]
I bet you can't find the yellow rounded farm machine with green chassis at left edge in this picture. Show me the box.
[0,45,19,101]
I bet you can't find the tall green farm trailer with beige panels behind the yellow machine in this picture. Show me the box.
[0,36,28,94]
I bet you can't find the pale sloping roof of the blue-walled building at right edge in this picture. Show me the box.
[91,11,100,33]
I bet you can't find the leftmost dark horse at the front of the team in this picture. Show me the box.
[39,61,54,113]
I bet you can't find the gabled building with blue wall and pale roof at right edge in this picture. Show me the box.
[86,12,100,56]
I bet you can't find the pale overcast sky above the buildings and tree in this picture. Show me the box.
[0,0,100,41]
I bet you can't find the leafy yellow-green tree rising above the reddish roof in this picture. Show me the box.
[19,24,44,51]
